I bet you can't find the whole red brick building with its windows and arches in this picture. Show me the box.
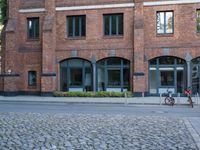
[0,0,200,95]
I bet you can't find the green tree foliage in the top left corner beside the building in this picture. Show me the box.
[0,0,7,24]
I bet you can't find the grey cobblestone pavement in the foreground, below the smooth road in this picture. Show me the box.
[0,113,198,150]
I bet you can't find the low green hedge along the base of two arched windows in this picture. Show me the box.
[53,91,133,97]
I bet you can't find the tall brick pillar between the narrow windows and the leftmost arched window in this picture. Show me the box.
[41,0,56,95]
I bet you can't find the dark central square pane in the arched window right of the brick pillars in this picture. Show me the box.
[160,70,174,86]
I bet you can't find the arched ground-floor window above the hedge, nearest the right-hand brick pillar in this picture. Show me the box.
[97,58,130,92]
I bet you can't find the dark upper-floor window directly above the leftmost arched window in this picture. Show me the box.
[67,16,86,37]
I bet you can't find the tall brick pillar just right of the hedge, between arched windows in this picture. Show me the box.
[133,0,145,96]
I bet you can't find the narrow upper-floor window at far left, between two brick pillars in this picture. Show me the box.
[27,18,39,39]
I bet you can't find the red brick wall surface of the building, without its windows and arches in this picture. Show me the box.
[0,0,200,94]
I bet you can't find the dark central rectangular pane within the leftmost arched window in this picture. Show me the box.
[70,68,83,86]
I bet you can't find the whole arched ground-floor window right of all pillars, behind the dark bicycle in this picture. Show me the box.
[149,56,186,94]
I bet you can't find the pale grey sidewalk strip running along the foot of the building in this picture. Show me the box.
[0,96,200,105]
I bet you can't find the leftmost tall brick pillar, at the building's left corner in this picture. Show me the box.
[1,0,20,96]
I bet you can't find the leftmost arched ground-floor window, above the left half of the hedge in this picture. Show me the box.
[60,59,92,91]
